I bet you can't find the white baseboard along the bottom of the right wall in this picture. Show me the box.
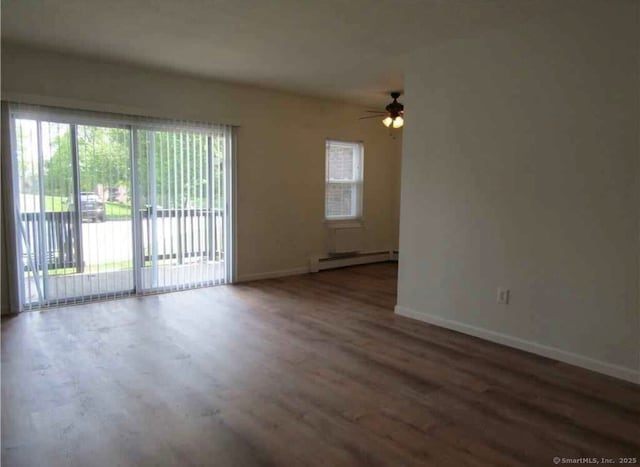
[395,305,640,384]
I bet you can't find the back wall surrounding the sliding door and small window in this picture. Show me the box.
[2,43,401,296]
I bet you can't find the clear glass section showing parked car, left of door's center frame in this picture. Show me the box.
[74,125,134,299]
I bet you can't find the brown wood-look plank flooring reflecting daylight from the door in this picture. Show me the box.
[2,263,640,467]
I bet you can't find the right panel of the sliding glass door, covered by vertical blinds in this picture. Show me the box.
[134,124,231,290]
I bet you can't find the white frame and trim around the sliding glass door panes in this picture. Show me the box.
[2,101,237,312]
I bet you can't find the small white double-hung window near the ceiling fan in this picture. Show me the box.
[324,141,364,220]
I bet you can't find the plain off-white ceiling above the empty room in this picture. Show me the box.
[2,0,566,105]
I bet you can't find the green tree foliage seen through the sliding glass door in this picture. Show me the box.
[40,125,224,209]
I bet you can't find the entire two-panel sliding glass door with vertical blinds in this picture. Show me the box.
[11,107,232,309]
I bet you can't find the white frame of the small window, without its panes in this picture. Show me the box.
[324,139,364,225]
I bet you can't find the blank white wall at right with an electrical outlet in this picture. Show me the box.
[397,1,640,381]
